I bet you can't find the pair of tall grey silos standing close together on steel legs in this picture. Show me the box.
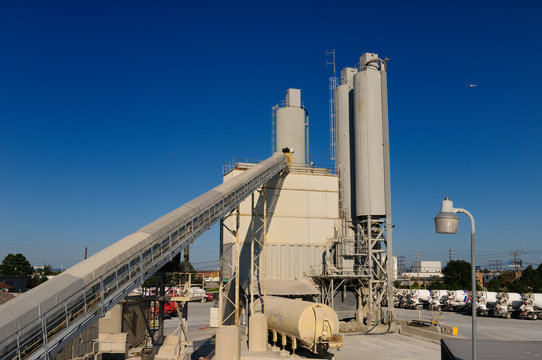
[335,53,388,225]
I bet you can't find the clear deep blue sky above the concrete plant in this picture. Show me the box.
[0,1,542,267]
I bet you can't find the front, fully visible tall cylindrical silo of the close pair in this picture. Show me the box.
[354,53,386,217]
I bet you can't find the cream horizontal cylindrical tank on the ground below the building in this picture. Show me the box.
[264,296,342,351]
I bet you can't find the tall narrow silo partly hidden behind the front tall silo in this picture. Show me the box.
[335,67,358,221]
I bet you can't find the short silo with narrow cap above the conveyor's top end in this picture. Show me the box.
[276,89,308,165]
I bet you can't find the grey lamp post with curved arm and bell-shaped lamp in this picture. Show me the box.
[435,197,476,360]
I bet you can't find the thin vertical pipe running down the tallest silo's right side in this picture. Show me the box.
[380,62,394,321]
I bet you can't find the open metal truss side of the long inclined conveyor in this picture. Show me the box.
[0,156,286,360]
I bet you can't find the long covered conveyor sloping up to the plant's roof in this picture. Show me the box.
[0,153,287,360]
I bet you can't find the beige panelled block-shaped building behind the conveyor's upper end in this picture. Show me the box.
[221,163,340,316]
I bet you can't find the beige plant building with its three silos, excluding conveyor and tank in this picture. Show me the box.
[221,53,397,325]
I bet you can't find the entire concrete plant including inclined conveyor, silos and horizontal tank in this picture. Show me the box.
[0,53,397,359]
